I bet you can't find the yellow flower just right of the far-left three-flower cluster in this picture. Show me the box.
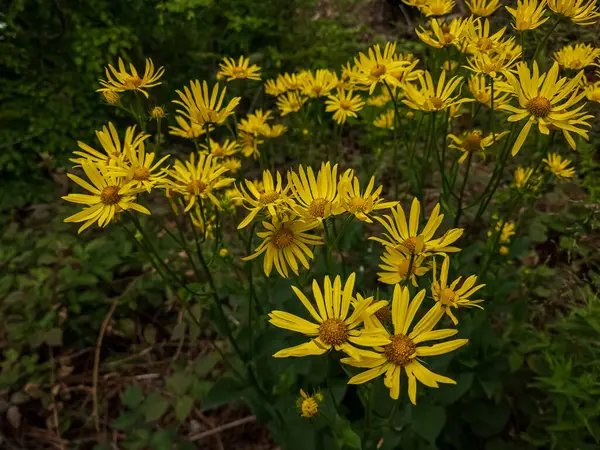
[168,153,234,212]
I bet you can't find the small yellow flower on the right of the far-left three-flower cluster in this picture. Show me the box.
[106,142,170,192]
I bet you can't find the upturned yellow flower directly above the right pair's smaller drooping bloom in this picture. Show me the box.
[369,198,463,256]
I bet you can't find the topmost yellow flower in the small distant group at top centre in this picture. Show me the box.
[354,42,414,94]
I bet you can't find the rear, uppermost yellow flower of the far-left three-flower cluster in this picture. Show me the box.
[69,122,150,167]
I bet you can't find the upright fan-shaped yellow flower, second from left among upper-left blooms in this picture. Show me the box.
[173,80,241,127]
